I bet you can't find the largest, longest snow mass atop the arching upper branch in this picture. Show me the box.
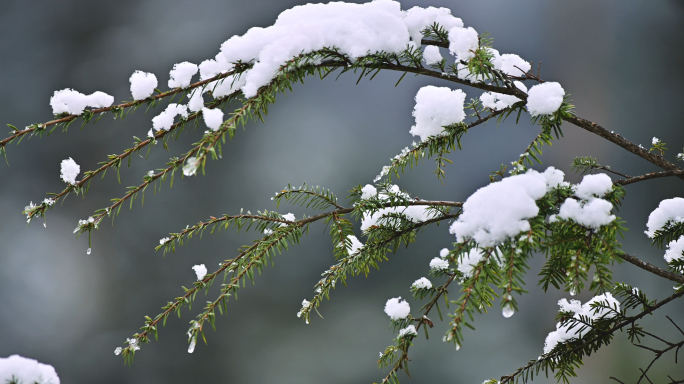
[221,1,409,98]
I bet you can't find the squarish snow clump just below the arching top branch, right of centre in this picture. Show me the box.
[410,85,466,140]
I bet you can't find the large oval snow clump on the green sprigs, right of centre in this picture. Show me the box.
[449,170,549,247]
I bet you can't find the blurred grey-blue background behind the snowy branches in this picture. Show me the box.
[0,0,684,384]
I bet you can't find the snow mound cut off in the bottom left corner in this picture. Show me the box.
[0,355,60,384]
